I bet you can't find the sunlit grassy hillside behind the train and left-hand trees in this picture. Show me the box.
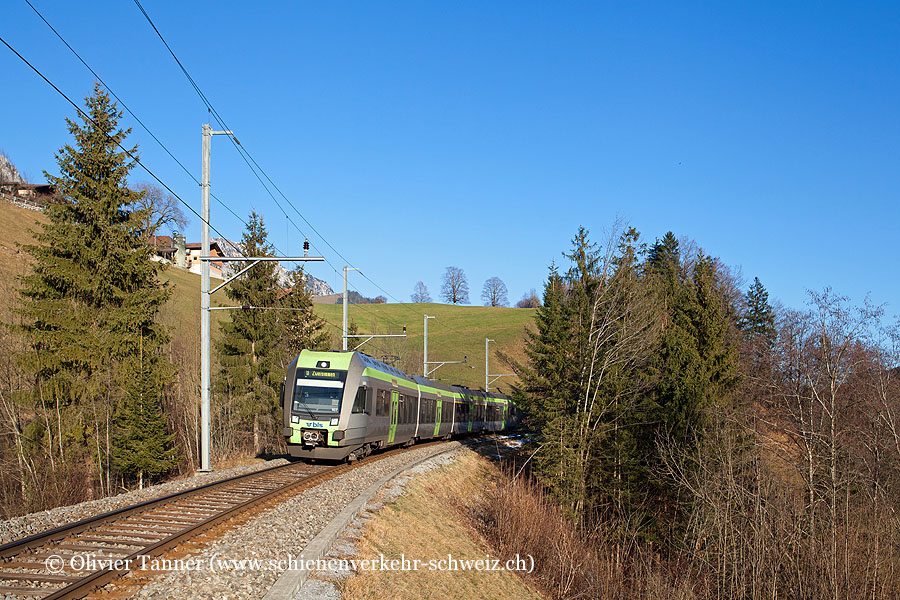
[0,203,534,390]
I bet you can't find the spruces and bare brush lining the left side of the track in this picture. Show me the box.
[0,85,331,516]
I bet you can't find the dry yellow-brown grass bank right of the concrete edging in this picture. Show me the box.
[343,453,542,600]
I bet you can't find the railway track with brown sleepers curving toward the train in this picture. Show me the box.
[0,442,440,600]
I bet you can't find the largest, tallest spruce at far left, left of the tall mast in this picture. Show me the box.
[18,84,171,488]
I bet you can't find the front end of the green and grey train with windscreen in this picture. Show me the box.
[281,350,365,460]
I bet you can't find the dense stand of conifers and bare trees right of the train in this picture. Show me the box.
[507,229,900,599]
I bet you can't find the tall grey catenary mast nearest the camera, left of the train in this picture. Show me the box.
[200,123,212,471]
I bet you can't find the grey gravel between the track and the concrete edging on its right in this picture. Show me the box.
[115,442,462,600]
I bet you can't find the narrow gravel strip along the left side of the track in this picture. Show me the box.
[0,458,288,545]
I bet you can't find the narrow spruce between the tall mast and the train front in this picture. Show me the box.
[216,211,284,454]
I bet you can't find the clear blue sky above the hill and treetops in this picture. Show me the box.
[0,0,900,315]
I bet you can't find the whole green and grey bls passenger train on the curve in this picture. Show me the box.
[281,350,521,460]
